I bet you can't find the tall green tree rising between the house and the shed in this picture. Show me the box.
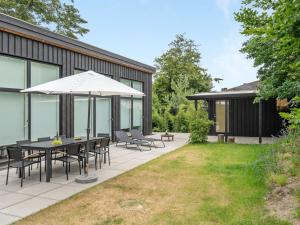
[153,34,212,107]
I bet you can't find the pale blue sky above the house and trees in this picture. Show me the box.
[75,0,256,90]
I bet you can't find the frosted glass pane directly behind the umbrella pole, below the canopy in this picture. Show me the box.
[74,96,93,136]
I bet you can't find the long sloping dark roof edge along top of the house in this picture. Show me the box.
[0,13,156,74]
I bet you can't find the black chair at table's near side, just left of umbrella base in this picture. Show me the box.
[55,143,82,180]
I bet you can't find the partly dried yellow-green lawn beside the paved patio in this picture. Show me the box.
[17,144,289,225]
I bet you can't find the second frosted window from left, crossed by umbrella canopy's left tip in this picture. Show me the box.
[31,62,59,140]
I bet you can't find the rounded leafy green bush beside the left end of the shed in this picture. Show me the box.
[189,107,213,143]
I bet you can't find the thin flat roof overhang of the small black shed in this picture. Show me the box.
[187,90,257,100]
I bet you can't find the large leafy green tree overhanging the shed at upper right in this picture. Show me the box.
[235,0,300,99]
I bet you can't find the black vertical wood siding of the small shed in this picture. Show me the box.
[208,97,282,137]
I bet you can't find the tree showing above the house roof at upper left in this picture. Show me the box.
[0,0,89,39]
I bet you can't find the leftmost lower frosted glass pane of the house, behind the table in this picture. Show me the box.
[0,92,28,145]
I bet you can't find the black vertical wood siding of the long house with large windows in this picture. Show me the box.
[0,31,152,136]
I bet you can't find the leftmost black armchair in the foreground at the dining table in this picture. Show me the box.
[6,146,42,187]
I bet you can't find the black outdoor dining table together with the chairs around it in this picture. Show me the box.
[6,134,110,187]
